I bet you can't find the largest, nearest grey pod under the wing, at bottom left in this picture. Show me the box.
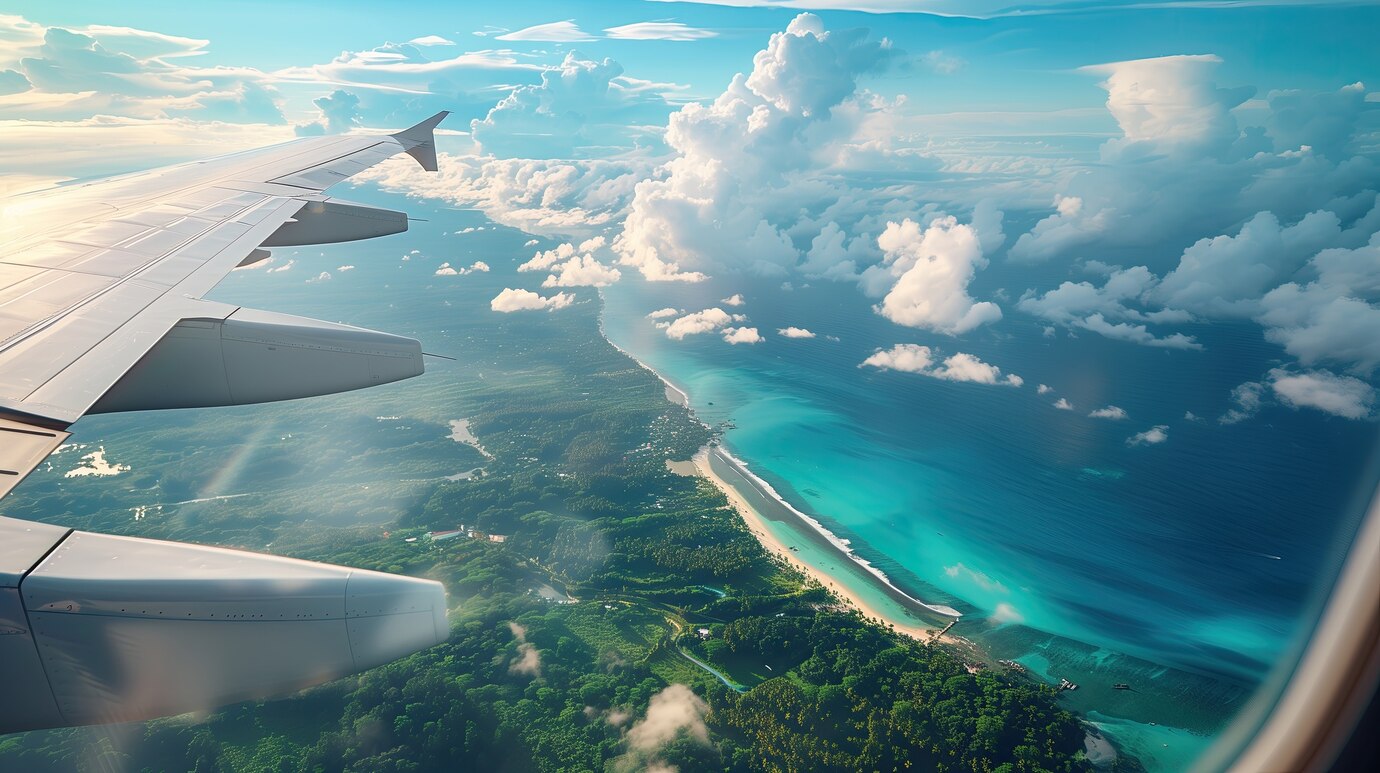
[0,518,450,733]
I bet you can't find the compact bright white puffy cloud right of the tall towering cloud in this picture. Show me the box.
[876,217,1002,335]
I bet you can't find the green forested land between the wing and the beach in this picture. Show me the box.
[0,296,1104,773]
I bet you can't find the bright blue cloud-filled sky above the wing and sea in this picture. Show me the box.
[0,0,1380,422]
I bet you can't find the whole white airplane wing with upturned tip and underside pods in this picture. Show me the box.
[0,112,449,733]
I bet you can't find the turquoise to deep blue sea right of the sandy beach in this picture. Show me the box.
[604,276,1377,769]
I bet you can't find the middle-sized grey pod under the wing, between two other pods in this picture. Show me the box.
[90,309,425,413]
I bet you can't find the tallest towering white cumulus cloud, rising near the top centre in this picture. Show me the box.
[614,14,891,282]
